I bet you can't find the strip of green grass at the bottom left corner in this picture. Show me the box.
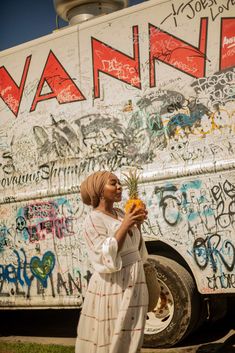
[0,342,74,353]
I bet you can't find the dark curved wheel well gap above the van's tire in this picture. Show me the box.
[145,240,195,281]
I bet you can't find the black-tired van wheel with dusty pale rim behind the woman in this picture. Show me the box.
[144,255,201,347]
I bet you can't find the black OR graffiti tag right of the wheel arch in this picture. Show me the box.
[193,234,235,273]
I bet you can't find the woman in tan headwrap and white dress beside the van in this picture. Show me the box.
[76,171,148,353]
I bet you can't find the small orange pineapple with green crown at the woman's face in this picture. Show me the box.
[123,170,145,212]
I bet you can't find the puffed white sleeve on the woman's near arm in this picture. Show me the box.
[83,212,122,273]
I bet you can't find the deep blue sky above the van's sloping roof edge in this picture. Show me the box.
[0,0,143,51]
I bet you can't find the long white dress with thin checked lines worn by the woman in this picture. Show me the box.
[75,209,148,353]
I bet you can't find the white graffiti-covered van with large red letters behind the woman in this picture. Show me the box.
[0,0,235,346]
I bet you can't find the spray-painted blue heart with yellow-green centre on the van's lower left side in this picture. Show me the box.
[30,251,55,288]
